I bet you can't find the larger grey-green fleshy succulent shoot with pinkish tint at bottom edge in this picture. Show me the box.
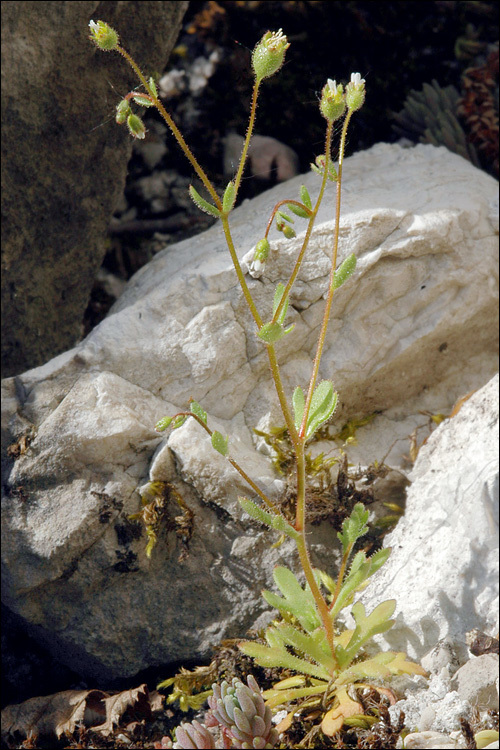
[208,675,278,750]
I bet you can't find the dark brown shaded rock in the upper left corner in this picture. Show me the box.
[2,2,188,375]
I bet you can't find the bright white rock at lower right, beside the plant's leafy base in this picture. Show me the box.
[363,376,499,659]
